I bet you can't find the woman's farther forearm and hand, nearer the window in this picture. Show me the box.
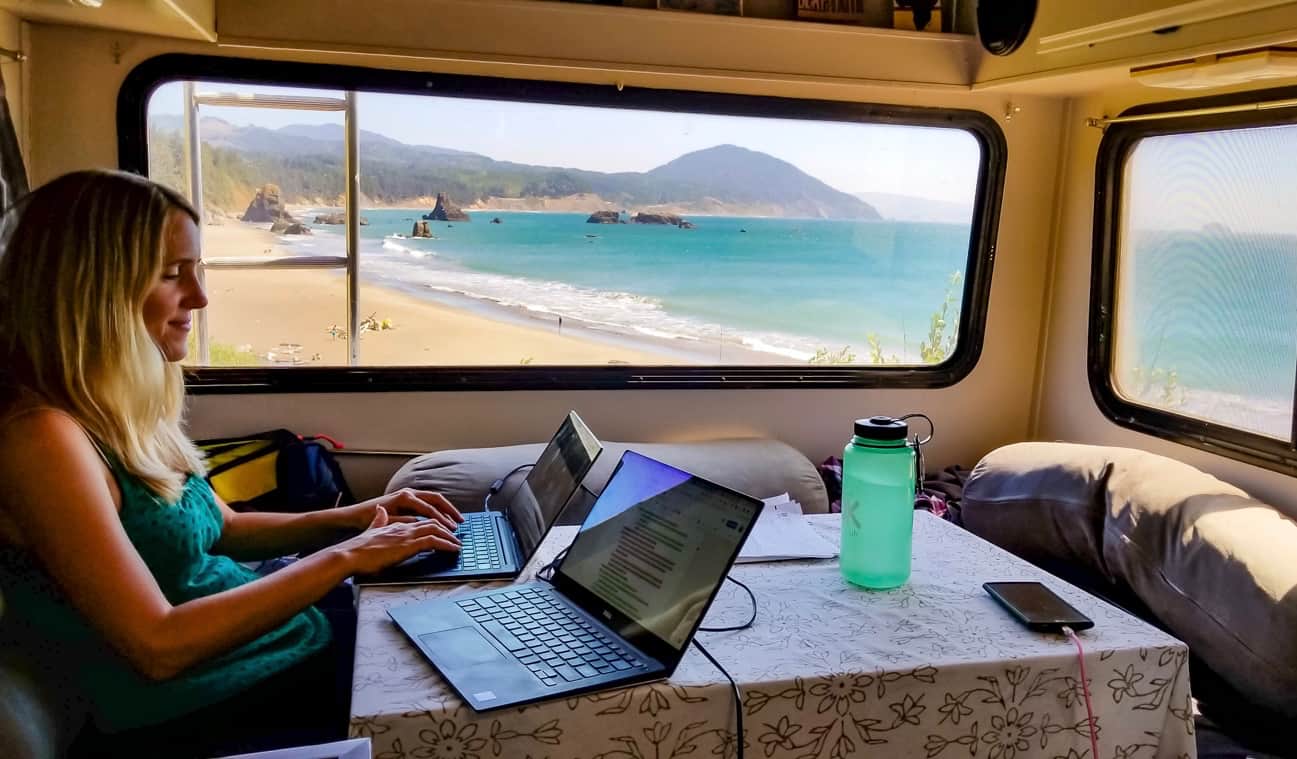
[214,488,464,562]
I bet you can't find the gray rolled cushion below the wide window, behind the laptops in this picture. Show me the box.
[388,439,829,514]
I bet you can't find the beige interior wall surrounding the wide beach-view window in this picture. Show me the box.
[30,25,1062,492]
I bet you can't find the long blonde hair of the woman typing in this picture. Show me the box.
[0,170,205,501]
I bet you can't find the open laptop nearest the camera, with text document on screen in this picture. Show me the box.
[388,450,761,710]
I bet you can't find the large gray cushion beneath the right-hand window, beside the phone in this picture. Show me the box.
[961,442,1297,717]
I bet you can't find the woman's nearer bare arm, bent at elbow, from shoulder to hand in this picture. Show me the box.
[0,411,457,680]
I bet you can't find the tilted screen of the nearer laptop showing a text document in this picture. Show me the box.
[562,452,759,649]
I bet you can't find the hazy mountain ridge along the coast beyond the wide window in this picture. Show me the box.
[149,115,882,221]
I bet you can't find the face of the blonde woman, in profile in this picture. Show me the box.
[144,210,208,361]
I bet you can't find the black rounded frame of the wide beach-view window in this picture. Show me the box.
[117,53,1008,393]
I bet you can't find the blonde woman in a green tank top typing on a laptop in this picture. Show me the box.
[0,171,462,756]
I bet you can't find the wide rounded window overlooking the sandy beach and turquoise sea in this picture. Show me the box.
[122,57,1003,388]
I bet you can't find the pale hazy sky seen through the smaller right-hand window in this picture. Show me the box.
[1126,126,1297,235]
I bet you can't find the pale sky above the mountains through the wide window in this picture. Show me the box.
[149,83,981,208]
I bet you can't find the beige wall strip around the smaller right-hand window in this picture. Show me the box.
[1035,84,1297,515]
